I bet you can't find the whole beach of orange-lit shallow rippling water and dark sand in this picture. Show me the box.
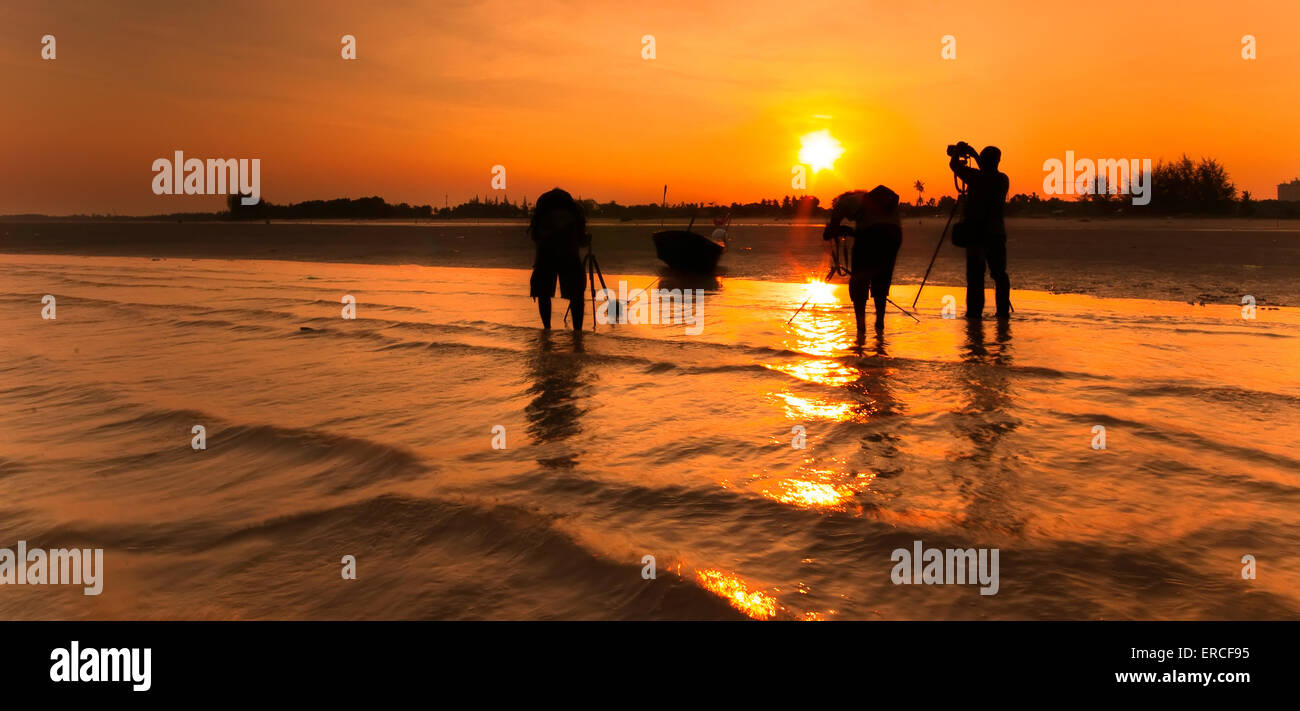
[0,231,1300,620]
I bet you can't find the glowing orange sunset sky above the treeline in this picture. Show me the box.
[0,0,1300,214]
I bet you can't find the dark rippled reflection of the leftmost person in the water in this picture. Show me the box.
[524,331,586,469]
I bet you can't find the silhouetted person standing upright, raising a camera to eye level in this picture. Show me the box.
[948,142,1011,318]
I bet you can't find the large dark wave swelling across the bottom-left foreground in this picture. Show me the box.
[5,494,744,620]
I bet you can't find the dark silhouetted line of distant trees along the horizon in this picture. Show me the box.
[10,156,1300,220]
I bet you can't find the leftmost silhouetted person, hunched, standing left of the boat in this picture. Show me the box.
[528,187,590,331]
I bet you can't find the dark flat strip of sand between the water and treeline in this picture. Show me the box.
[0,218,1300,305]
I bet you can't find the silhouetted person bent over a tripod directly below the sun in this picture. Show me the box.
[822,185,902,344]
